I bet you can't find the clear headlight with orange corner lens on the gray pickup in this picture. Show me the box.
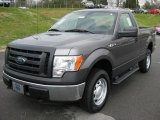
[52,56,83,77]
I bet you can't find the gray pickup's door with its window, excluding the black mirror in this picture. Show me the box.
[112,13,138,75]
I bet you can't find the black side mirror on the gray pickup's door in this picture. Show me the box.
[118,27,138,37]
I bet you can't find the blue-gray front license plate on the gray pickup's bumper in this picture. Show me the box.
[12,82,24,94]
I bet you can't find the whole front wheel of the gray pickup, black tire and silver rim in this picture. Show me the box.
[82,69,110,113]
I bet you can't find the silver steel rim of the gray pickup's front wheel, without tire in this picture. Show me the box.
[93,78,107,105]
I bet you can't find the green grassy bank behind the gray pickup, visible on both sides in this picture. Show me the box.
[0,7,160,49]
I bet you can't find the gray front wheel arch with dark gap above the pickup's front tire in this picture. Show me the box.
[81,49,115,81]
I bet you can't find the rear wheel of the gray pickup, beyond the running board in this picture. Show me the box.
[138,49,151,73]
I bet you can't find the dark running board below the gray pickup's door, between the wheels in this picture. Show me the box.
[112,67,139,85]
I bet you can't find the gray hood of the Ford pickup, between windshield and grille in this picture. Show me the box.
[10,32,111,48]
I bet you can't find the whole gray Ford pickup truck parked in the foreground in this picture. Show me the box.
[3,9,155,112]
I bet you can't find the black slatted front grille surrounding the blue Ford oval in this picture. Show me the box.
[6,48,50,77]
